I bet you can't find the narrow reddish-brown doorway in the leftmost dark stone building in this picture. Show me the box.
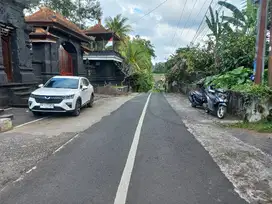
[1,35,13,82]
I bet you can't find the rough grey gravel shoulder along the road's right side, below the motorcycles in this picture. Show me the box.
[165,94,272,204]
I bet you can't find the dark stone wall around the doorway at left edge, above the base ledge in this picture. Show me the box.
[0,0,36,84]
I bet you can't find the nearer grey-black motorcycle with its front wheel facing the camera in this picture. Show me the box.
[203,87,228,119]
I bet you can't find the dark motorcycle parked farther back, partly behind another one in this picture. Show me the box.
[188,84,207,108]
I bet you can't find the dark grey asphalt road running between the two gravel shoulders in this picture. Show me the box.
[0,94,246,204]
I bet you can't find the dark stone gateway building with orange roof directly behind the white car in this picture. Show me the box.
[25,7,91,82]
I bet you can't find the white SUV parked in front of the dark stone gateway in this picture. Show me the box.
[28,76,94,116]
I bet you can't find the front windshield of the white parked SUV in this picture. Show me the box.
[44,78,79,89]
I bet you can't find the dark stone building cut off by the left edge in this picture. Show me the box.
[0,0,36,107]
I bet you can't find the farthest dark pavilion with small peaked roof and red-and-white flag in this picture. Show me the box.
[83,20,125,85]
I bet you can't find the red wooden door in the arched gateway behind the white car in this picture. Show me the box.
[59,46,74,76]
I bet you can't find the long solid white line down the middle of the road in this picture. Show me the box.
[114,93,151,204]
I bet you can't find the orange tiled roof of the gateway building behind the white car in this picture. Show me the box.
[25,7,88,40]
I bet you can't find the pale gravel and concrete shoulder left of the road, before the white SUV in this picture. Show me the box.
[0,94,137,191]
